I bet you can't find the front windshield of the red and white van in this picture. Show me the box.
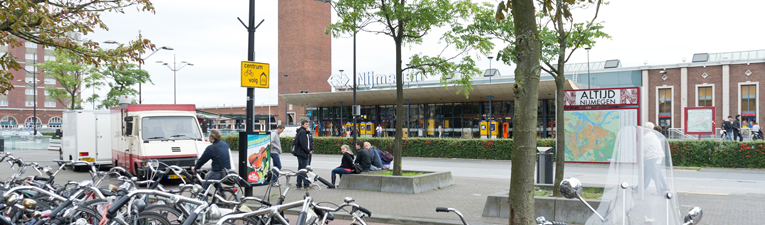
[141,116,202,140]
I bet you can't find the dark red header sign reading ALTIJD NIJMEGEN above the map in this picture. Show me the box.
[564,87,640,106]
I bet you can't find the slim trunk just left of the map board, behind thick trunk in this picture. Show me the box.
[553,0,566,197]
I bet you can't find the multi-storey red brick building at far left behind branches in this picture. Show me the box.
[0,38,73,129]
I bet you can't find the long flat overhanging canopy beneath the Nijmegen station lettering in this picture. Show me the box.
[279,79,579,107]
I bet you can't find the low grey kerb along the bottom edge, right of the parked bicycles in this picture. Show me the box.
[284,209,502,225]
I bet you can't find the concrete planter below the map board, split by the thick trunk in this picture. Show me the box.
[483,192,608,223]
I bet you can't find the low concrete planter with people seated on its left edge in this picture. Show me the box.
[339,171,454,194]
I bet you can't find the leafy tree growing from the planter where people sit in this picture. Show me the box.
[327,0,493,176]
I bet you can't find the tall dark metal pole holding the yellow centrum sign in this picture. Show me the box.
[239,0,255,196]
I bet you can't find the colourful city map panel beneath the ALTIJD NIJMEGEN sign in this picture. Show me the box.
[563,108,639,163]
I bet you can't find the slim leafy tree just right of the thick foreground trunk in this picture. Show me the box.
[540,0,611,197]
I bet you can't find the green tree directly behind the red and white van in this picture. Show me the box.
[88,64,153,109]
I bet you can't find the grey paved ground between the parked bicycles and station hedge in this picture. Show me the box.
[0,151,765,224]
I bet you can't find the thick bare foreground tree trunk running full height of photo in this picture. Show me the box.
[509,0,541,225]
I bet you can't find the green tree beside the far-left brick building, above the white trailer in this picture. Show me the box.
[35,49,94,109]
